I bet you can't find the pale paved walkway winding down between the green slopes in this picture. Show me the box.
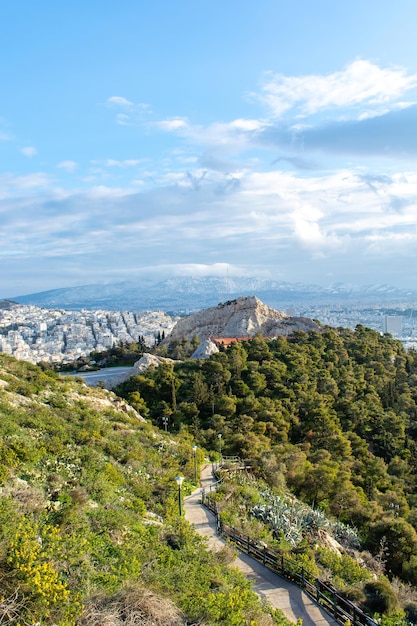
[184,465,337,626]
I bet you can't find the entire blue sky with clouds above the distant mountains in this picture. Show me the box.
[0,0,417,298]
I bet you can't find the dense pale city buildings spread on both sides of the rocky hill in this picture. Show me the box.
[0,305,417,363]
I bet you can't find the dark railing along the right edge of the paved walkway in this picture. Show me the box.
[202,485,379,626]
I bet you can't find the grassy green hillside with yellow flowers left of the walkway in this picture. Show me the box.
[0,355,287,626]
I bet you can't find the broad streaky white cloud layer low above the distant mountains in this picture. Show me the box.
[0,166,417,292]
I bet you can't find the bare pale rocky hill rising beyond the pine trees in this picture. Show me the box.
[166,296,320,343]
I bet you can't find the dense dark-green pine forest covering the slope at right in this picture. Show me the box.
[116,326,417,613]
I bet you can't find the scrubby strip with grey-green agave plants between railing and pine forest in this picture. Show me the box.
[205,469,374,600]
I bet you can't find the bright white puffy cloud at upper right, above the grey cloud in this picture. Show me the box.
[258,60,417,117]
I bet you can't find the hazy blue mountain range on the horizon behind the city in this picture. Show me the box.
[14,276,417,313]
